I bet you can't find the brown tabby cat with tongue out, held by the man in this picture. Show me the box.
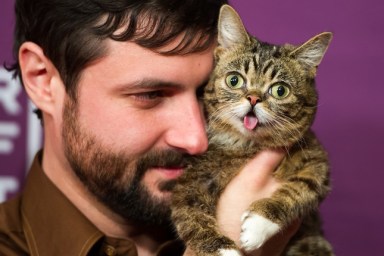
[172,5,333,256]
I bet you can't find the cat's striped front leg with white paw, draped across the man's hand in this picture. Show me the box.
[240,173,321,252]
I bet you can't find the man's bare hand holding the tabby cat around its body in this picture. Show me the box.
[217,151,300,256]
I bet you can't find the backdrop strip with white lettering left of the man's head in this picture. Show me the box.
[0,0,42,202]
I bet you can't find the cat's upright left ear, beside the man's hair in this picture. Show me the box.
[218,5,250,48]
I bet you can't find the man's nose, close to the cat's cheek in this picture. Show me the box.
[166,99,208,155]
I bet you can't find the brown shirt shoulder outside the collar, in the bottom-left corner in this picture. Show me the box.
[0,196,27,255]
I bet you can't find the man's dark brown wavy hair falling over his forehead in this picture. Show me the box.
[8,0,226,118]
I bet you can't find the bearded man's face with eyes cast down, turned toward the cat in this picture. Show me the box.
[62,41,213,224]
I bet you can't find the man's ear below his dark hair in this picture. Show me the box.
[19,42,61,114]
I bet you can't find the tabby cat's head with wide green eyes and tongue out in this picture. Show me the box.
[204,5,332,147]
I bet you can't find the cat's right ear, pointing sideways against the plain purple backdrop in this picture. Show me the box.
[290,32,333,69]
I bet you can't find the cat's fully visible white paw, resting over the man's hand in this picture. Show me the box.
[240,212,280,252]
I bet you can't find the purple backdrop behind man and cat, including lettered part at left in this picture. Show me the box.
[0,0,384,256]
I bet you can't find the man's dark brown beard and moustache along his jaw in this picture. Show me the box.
[62,99,183,226]
